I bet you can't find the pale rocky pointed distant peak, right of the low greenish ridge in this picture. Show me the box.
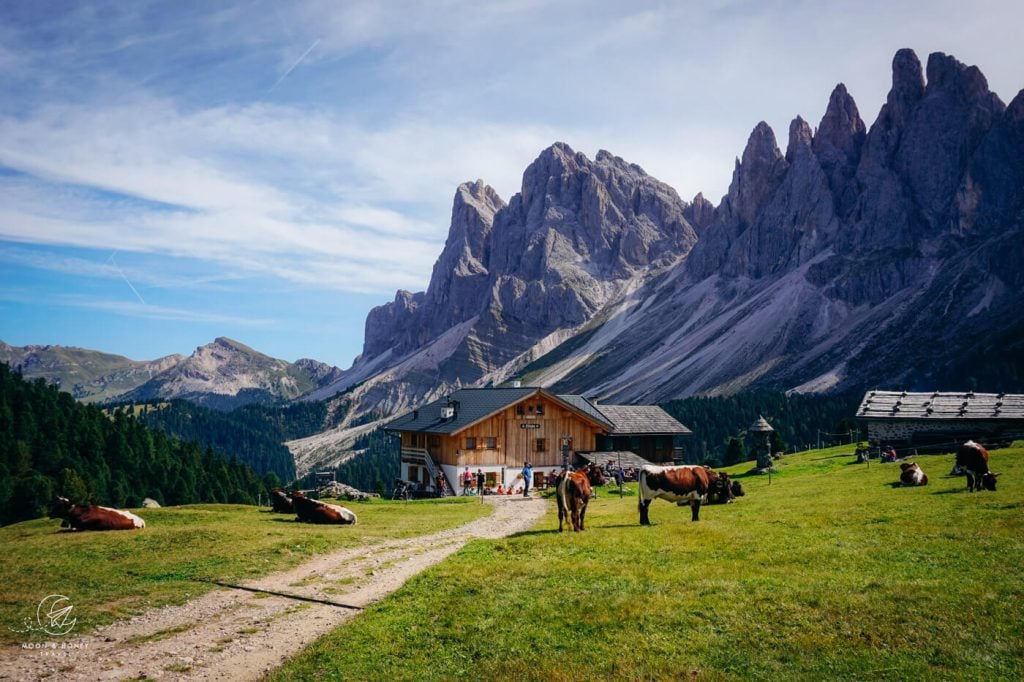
[120,337,341,410]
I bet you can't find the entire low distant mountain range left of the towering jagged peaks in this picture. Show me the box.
[0,337,341,410]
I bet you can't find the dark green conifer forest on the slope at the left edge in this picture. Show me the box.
[0,364,263,524]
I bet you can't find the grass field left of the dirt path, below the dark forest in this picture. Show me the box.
[0,491,490,642]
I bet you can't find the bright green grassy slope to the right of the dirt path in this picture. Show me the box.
[273,449,1024,680]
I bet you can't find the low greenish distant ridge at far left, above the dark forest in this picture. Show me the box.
[0,341,184,402]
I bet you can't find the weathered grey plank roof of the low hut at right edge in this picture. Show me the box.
[857,390,1024,420]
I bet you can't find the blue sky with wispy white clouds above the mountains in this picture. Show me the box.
[0,0,1024,367]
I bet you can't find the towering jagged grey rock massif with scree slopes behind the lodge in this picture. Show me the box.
[310,50,1024,419]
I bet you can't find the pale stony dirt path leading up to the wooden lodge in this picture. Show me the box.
[0,498,546,680]
